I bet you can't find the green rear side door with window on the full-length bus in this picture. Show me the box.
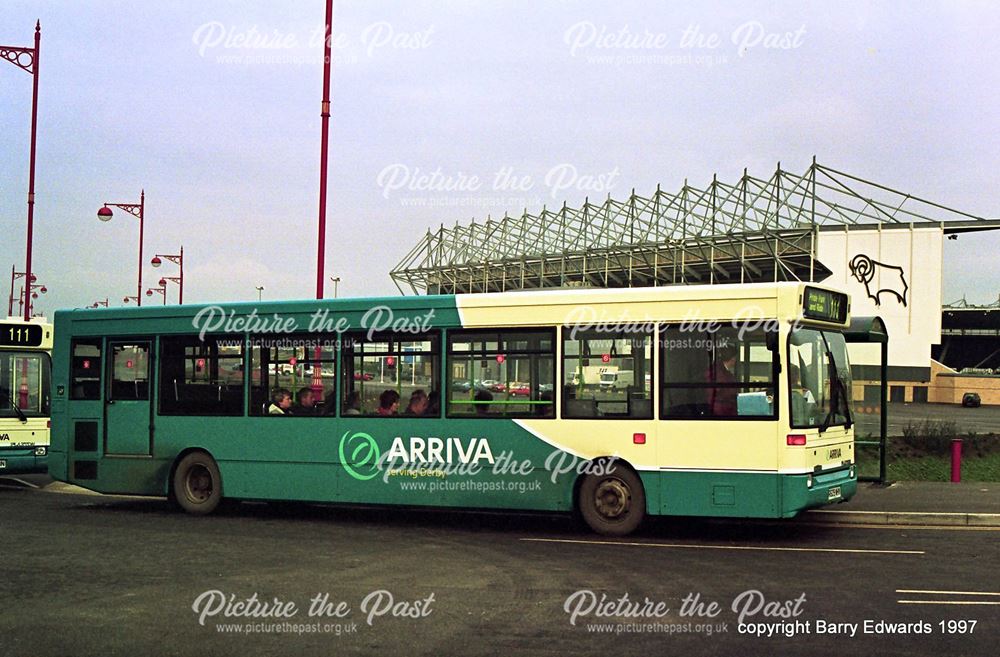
[104,340,153,456]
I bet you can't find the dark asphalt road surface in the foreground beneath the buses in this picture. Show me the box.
[0,476,1000,657]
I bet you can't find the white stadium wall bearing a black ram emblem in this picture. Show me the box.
[817,226,944,378]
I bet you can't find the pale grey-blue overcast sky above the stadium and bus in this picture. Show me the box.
[0,0,1000,315]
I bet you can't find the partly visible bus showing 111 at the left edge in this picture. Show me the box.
[0,317,52,475]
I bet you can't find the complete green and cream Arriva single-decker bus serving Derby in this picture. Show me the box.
[50,283,857,535]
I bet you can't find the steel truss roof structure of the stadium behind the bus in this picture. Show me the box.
[390,158,998,294]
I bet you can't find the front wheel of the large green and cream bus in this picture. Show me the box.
[577,465,646,536]
